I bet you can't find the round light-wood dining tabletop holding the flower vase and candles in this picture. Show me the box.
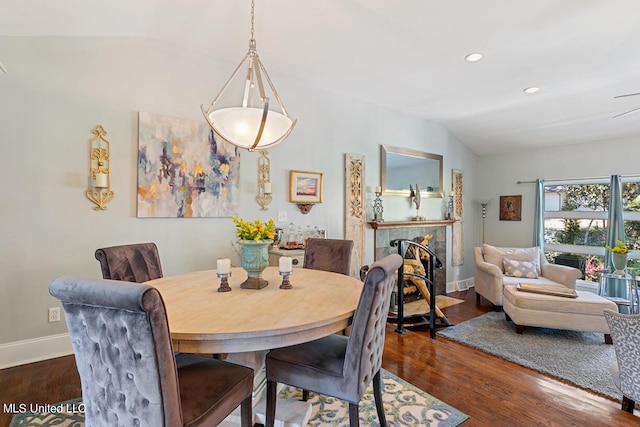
[145,267,363,353]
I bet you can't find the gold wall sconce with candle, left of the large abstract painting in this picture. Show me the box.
[85,125,115,211]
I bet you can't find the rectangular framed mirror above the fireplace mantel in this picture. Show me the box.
[380,145,443,197]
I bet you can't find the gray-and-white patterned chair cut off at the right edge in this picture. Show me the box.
[604,310,640,414]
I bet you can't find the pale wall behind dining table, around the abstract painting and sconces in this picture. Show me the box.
[0,37,479,352]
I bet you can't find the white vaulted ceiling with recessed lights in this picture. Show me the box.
[0,0,640,155]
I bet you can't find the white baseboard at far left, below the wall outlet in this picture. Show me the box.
[0,333,73,369]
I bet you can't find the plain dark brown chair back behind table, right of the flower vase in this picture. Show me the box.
[302,238,353,276]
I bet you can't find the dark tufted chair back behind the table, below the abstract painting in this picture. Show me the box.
[95,243,162,283]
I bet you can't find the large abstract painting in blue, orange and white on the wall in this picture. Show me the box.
[137,112,240,218]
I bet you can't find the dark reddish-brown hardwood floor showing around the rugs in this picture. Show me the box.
[0,289,640,427]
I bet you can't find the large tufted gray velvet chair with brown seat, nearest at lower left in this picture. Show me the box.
[49,277,253,427]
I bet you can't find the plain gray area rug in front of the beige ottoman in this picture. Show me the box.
[437,312,622,401]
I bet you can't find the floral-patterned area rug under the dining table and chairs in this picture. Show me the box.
[9,370,469,427]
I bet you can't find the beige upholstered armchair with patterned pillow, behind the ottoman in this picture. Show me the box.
[474,244,582,306]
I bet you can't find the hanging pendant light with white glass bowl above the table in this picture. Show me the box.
[200,0,297,151]
